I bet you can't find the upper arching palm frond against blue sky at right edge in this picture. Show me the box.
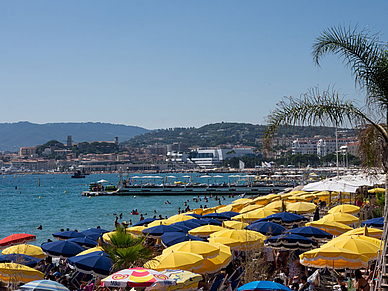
[312,26,388,113]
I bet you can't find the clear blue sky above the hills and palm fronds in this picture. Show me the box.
[0,0,388,129]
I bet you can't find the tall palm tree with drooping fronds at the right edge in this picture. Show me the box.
[265,27,388,290]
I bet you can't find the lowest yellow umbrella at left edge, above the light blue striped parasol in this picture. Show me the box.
[0,263,44,283]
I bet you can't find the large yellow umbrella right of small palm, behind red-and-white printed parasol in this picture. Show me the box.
[144,251,204,271]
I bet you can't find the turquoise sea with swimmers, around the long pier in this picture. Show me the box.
[0,173,249,245]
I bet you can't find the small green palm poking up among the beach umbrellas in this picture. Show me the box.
[101,226,153,271]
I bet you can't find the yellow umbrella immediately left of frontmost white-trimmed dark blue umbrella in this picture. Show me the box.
[210,229,266,247]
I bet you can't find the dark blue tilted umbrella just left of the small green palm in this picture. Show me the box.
[67,252,112,277]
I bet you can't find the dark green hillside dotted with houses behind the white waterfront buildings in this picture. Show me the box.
[123,122,346,147]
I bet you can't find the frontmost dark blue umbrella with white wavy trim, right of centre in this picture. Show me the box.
[264,233,318,251]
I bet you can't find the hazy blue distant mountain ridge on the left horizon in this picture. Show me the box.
[0,121,149,152]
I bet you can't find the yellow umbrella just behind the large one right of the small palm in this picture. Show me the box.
[163,240,220,259]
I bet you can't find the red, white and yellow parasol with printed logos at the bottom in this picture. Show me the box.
[101,267,176,288]
